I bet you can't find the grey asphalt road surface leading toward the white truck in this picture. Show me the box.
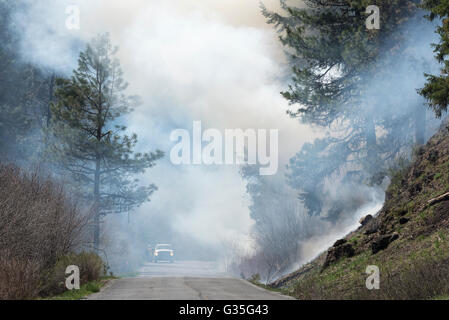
[88,261,290,300]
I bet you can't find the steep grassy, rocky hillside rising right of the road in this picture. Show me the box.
[271,119,449,299]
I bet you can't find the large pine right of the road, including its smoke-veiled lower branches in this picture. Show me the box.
[262,0,422,219]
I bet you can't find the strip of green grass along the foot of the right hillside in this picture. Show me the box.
[285,229,449,300]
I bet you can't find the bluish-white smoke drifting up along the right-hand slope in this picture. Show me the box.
[222,6,439,281]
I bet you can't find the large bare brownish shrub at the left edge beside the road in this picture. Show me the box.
[0,164,95,299]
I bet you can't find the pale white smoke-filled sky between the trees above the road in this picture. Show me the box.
[16,0,316,254]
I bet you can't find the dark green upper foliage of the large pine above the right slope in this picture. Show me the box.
[263,0,416,125]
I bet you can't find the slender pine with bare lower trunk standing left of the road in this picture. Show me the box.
[48,34,163,249]
